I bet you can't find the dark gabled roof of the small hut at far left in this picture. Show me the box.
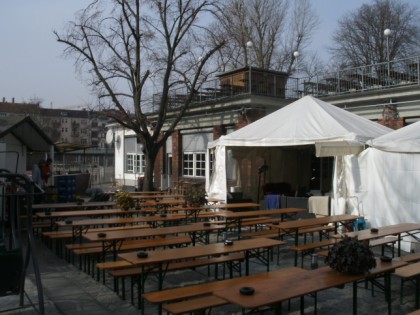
[0,116,54,152]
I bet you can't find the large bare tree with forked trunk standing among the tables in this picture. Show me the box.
[54,0,224,190]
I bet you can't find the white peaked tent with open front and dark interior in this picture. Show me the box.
[207,96,391,210]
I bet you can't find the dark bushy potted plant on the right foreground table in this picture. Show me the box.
[325,236,376,274]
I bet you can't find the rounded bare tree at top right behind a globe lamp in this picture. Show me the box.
[331,0,420,67]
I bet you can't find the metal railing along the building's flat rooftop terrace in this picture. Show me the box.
[153,57,420,111]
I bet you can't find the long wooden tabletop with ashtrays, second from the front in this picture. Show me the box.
[118,238,285,266]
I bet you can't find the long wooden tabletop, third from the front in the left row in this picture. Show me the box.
[83,222,224,242]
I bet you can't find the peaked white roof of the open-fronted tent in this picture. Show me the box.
[209,96,392,151]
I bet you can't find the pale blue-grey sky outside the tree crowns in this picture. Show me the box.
[0,0,418,109]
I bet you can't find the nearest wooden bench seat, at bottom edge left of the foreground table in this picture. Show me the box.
[163,295,228,315]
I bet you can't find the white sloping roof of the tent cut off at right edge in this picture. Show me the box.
[367,121,420,153]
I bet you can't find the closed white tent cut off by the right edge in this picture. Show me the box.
[345,122,420,250]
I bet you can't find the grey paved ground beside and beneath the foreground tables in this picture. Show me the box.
[0,230,414,315]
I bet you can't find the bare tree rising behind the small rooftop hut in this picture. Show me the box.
[214,0,319,73]
